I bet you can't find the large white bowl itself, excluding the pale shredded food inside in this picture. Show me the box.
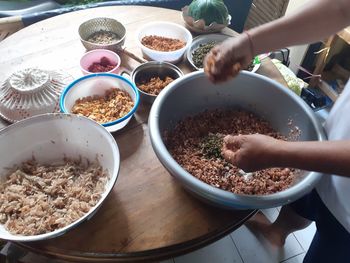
[0,113,120,242]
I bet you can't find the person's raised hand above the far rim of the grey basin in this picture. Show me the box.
[204,34,254,83]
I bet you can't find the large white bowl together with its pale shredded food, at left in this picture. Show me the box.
[0,113,120,242]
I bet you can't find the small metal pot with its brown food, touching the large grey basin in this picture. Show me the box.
[131,61,183,103]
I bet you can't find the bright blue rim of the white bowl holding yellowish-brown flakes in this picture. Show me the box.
[60,73,140,127]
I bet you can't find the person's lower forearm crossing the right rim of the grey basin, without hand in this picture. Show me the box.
[271,141,350,177]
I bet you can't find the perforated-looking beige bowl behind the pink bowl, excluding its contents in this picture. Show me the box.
[78,17,126,51]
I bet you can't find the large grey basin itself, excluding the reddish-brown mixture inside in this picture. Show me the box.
[149,71,325,209]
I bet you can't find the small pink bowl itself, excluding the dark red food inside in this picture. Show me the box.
[80,49,121,75]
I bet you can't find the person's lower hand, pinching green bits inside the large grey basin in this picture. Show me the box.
[222,134,283,172]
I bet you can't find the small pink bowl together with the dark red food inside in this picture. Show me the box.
[80,49,121,75]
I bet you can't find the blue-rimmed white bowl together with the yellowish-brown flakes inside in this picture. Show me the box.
[60,73,140,132]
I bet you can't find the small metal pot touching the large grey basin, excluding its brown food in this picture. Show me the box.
[131,61,183,103]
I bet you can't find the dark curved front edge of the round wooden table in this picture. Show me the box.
[14,209,258,262]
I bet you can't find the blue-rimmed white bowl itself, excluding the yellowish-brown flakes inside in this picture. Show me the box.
[60,73,140,132]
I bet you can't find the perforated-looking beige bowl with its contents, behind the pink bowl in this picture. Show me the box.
[78,17,126,51]
